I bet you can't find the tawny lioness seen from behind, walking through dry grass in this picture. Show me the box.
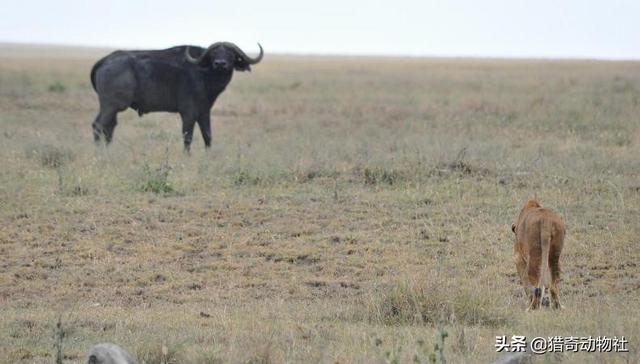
[511,200,565,311]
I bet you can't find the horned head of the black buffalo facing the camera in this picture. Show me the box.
[185,42,264,71]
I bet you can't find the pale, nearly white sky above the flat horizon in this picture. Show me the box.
[0,0,640,59]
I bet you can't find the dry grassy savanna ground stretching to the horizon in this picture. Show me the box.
[0,45,640,363]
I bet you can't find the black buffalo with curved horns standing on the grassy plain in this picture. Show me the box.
[91,42,264,151]
